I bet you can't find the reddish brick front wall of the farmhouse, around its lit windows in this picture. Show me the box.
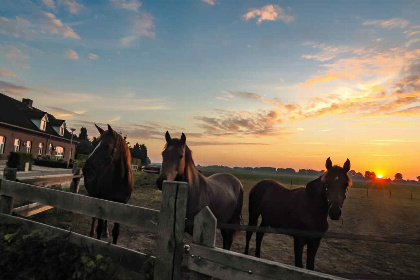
[0,124,76,161]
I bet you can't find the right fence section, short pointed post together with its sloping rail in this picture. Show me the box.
[188,207,344,280]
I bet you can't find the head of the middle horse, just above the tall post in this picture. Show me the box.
[156,131,188,190]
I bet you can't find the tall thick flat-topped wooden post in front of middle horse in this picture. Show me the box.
[154,181,188,280]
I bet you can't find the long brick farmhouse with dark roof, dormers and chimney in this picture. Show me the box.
[0,93,76,163]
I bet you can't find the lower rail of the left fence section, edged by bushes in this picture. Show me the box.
[0,214,155,273]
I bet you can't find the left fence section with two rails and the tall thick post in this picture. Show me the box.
[0,169,188,280]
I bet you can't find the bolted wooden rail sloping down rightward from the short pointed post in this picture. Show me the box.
[188,244,344,280]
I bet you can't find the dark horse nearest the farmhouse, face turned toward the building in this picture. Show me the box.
[83,124,134,244]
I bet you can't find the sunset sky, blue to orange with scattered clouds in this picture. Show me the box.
[0,0,420,179]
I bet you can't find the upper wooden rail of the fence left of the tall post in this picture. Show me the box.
[0,180,159,232]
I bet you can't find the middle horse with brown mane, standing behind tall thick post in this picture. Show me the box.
[156,131,243,250]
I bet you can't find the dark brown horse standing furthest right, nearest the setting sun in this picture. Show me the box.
[245,158,351,270]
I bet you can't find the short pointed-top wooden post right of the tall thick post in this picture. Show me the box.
[188,206,217,280]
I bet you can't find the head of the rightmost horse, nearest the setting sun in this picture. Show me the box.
[306,158,351,220]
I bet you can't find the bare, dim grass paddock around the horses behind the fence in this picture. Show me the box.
[27,171,420,279]
